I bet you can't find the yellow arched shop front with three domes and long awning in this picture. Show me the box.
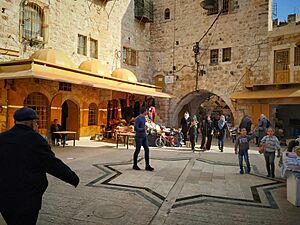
[0,49,172,138]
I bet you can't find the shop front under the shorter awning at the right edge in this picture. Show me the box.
[231,88,300,138]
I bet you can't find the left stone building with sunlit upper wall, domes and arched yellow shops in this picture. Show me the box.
[0,0,170,136]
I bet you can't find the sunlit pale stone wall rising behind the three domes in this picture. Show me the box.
[0,0,152,83]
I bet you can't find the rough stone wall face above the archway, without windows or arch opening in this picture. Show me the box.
[151,0,270,125]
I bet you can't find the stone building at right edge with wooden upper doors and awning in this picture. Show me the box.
[231,14,300,137]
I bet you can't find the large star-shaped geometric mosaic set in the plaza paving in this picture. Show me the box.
[87,157,285,209]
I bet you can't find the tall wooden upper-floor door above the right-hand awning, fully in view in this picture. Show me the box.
[274,49,290,83]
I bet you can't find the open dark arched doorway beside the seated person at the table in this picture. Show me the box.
[61,99,79,138]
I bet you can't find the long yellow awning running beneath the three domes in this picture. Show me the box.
[0,59,173,98]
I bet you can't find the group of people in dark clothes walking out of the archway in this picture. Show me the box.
[181,112,230,152]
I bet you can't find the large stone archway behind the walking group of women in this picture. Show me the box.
[170,90,235,127]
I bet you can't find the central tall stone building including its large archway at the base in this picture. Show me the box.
[151,0,269,126]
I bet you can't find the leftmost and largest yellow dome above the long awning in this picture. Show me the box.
[30,48,75,68]
